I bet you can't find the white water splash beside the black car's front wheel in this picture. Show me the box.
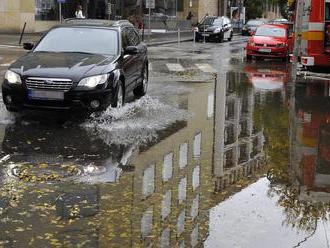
[82,96,190,145]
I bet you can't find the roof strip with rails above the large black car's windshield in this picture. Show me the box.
[64,18,133,27]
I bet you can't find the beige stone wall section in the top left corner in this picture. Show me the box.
[0,0,35,33]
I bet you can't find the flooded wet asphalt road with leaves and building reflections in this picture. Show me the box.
[0,37,330,248]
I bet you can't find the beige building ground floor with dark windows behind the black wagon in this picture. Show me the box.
[0,0,222,33]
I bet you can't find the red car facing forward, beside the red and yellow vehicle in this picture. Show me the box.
[246,24,292,59]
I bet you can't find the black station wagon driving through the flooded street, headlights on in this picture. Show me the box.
[2,19,148,112]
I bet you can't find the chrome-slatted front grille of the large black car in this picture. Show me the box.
[25,78,72,92]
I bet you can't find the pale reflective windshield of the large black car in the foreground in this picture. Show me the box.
[34,27,118,55]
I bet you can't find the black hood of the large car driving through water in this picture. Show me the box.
[9,52,116,82]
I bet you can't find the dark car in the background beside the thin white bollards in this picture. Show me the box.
[195,16,234,42]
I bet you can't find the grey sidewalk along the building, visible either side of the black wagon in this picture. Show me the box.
[0,30,193,47]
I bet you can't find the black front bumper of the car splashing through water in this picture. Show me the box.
[2,82,112,111]
